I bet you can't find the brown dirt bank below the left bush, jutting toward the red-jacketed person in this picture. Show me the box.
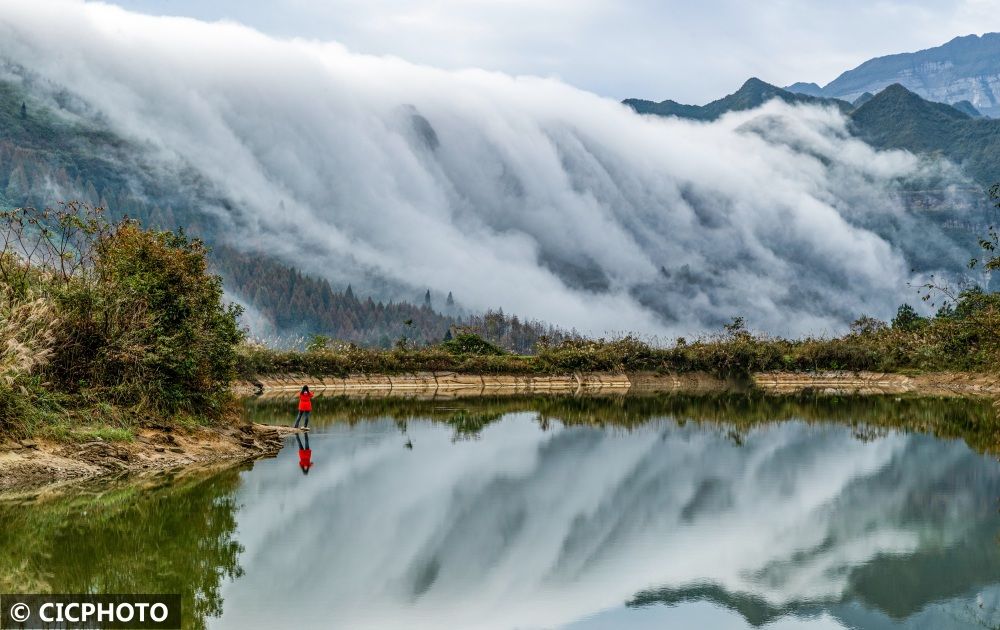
[0,424,294,499]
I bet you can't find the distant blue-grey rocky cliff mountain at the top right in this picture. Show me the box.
[823,33,1000,117]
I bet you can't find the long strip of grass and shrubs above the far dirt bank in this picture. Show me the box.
[238,290,1000,379]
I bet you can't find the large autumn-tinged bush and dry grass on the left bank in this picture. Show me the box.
[0,204,243,439]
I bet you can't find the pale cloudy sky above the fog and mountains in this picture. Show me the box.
[99,0,1000,103]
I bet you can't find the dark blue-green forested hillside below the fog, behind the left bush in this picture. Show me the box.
[0,69,566,352]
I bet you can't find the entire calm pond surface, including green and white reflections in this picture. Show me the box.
[0,398,1000,630]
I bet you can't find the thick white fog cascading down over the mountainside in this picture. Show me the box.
[0,0,976,335]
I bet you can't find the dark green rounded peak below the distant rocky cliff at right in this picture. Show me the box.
[850,84,1000,186]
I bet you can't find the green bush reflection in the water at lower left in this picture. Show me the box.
[0,469,243,628]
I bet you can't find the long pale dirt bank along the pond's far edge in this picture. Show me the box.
[237,372,1000,398]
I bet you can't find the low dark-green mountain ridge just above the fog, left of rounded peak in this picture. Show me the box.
[622,77,851,120]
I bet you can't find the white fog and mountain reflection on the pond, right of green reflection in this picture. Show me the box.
[220,400,1000,628]
